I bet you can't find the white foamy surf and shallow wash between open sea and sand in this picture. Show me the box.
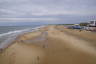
[0,26,44,49]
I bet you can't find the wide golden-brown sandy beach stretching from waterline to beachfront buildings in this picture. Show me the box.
[0,25,96,64]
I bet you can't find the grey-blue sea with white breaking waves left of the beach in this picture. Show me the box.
[0,25,43,49]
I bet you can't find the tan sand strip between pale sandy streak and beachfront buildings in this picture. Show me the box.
[56,26,96,47]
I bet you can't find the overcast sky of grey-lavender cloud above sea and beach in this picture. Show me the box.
[0,0,96,23]
